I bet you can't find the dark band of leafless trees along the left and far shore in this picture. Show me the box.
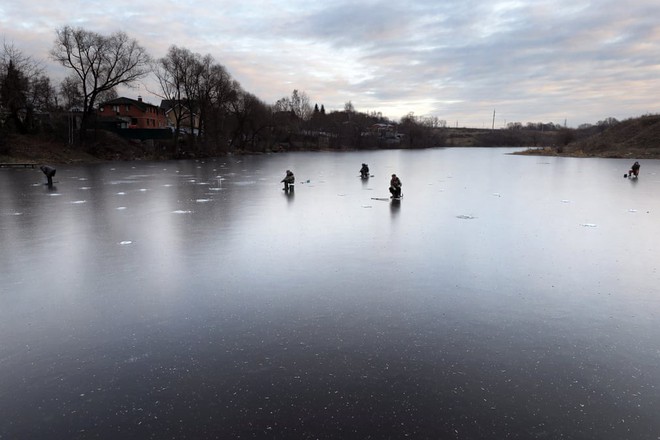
[0,26,612,157]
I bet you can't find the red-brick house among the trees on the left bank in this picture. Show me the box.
[98,96,167,129]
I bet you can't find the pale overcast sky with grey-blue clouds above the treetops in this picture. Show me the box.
[0,0,660,127]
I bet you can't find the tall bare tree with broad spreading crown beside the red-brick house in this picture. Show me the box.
[50,26,150,141]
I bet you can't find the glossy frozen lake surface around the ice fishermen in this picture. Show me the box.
[0,149,660,439]
